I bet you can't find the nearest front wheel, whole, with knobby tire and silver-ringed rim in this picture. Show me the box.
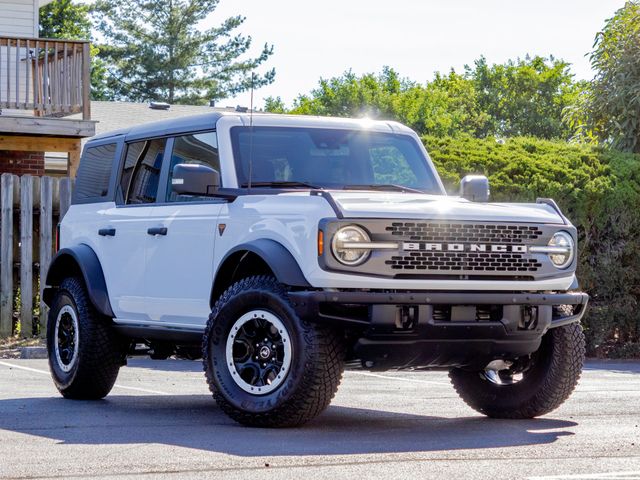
[202,276,344,427]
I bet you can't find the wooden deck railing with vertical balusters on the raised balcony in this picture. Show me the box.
[0,36,91,120]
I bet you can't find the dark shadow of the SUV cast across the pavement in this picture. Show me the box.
[0,395,577,456]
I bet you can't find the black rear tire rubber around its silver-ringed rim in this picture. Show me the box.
[47,277,126,400]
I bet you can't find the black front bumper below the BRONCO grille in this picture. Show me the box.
[289,291,589,369]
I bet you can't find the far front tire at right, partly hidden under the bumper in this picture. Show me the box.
[449,323,585,419]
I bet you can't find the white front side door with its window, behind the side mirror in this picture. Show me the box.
[144,131,225,330]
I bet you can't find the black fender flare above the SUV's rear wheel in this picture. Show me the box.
[42,243,115,318]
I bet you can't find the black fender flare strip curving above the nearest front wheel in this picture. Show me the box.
[211,238,311,300]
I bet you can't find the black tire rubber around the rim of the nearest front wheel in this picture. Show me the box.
[202,276,345,427]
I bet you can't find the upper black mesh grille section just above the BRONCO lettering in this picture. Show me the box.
[385,222,542,244]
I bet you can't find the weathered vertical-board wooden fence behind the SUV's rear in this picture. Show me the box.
[0,173,73,338]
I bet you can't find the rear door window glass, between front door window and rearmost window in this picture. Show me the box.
[120,138,166,204]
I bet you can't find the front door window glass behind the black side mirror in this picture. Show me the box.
[167,132,220,202]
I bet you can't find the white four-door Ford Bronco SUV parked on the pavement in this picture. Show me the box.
[44,112,588,427]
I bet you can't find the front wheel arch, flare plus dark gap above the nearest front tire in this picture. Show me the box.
[209,239,311,307]
